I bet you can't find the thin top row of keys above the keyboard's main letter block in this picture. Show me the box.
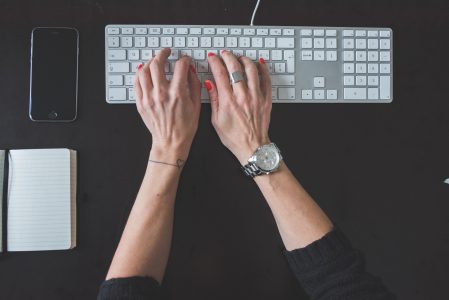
[107,27,295,36]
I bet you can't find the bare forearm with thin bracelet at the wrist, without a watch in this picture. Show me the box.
[107,150,182,283]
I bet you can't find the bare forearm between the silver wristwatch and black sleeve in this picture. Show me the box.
[254,162,332,250]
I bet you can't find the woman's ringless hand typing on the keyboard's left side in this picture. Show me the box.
[134,48,201,163]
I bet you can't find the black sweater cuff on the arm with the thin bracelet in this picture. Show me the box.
[97,276,162,300]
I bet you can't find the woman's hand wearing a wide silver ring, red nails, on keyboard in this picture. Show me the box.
[205,50,272,165]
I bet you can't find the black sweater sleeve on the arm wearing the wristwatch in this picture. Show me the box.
[284,229,396,300]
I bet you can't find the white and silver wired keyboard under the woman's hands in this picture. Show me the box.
[105,24,393,104]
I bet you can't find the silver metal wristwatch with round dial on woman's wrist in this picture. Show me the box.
[242,143,282,177]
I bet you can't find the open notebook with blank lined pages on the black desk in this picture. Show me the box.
[0,149,76,251]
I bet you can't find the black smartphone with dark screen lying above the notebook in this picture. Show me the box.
[29,27,79,122]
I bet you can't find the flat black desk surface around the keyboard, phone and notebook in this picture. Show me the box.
[0,0,449,300]
